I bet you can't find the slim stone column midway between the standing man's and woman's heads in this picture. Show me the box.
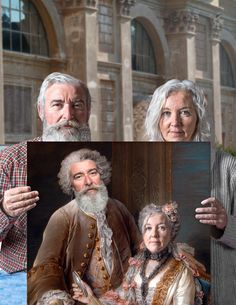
[119,0,135,141]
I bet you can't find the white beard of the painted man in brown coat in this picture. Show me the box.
[74,184,108,214]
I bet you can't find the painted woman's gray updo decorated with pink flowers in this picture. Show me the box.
[138,202,180,241]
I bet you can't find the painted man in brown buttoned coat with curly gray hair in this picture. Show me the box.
[28,149,140,305]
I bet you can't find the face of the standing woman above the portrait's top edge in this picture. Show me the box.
[159,91,197,142]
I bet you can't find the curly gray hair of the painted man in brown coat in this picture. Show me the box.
[58,148,111,195]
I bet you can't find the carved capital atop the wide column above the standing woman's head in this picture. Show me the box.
[164,11,199,33]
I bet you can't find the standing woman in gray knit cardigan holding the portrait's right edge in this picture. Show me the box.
[145,79,236,305]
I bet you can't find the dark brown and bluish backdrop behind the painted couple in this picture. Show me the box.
[28,142,210,270]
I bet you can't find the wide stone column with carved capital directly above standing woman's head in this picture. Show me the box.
[165,10,198,81]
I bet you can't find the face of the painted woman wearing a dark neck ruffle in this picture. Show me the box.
[143,214,171,253]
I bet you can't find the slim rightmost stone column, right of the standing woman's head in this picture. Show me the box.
[211,15,223,144]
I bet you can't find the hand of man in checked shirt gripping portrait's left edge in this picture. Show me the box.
[2,186,39,217]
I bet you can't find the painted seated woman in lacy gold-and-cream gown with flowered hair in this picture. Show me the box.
[73,202,205,305]
